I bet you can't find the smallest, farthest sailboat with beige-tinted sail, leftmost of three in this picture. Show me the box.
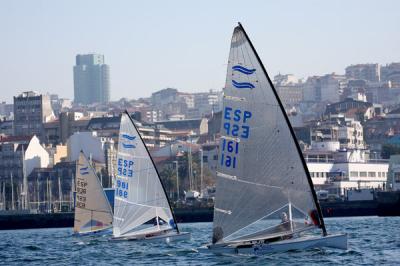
[74,152,113,235]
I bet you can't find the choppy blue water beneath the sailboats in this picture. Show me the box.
[0,217,400,265]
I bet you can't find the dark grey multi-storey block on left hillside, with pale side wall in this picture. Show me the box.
[14,91,54,141]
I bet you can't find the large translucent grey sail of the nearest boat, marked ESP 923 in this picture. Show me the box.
[213,23,322,243]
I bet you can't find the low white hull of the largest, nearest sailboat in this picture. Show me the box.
[208,234,347,255]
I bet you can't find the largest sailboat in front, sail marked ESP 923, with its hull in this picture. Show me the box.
[207,23,347,254]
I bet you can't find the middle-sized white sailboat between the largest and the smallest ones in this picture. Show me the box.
[113,112,190,242]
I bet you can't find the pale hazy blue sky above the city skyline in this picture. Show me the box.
[0,0,400,103]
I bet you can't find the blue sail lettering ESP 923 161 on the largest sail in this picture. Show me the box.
[220,106,252,168]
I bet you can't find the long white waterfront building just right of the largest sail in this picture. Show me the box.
[303,141,389,195]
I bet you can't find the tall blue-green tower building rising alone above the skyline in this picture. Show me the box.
[74,54,110,104]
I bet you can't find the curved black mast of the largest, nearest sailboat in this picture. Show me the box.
[238,22,327,236]
